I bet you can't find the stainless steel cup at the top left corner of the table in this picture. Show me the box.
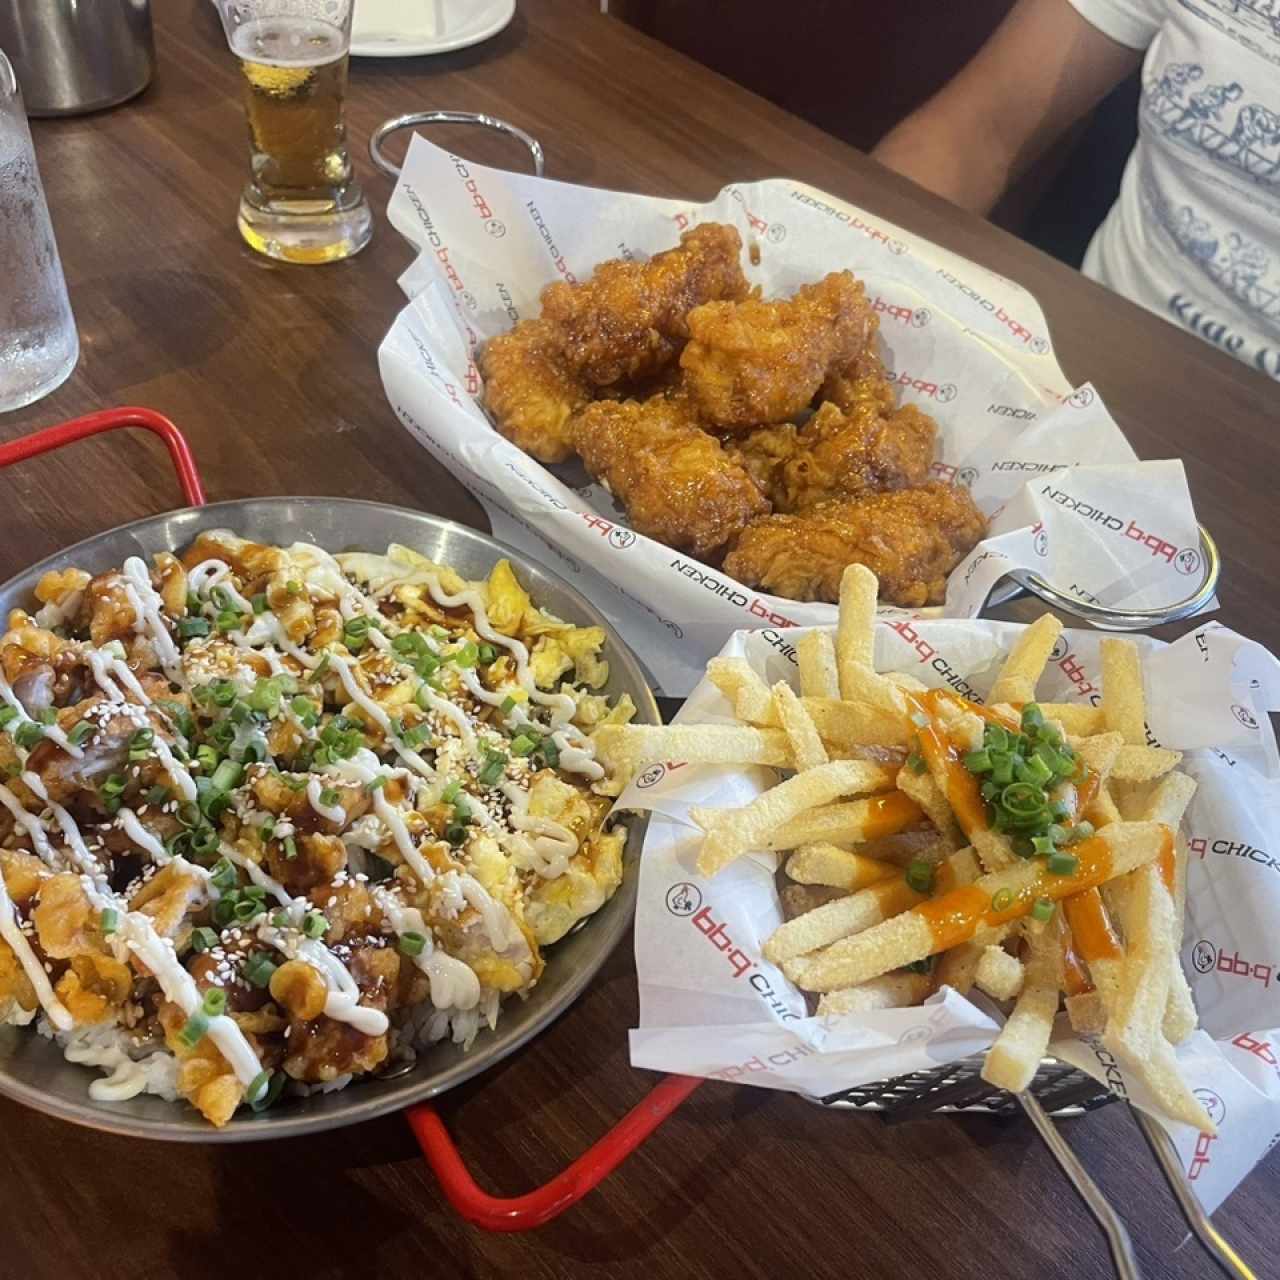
[0,0,156,115]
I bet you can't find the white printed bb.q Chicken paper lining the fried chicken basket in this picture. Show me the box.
[378,137,1203,695]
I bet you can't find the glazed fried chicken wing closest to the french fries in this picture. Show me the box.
[724,483,987,607]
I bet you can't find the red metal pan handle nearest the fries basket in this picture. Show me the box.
[404,1075,703,1231]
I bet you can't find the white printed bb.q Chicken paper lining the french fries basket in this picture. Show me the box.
[618,618,1280,1211]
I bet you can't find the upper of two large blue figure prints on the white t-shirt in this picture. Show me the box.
[1143,63,1280,195]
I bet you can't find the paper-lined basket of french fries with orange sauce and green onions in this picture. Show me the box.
[598,566,1280,1210]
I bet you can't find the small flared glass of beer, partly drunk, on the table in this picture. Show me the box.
[218,0,374,262]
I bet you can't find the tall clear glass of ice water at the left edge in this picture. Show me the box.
[0,50,79,413]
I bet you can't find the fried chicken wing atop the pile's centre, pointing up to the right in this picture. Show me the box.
[680,271,876,430]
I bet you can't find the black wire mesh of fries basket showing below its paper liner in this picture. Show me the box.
[813,1055,1115,1124]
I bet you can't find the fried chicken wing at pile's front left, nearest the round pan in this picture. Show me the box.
[573,396,769,559]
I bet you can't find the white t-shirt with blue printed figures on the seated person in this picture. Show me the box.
[1070,0,1280,379]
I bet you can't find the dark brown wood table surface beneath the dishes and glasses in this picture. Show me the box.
[0,0,1280,1280]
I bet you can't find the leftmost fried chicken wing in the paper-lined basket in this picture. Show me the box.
[480,320,591,462]
